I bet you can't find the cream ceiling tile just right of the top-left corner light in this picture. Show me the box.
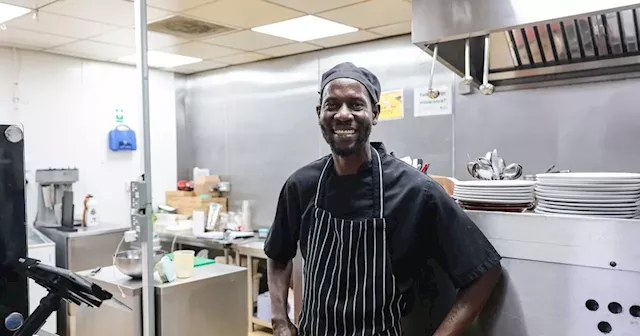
[6,12,116,38]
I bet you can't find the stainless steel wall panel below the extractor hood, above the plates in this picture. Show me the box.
[454,79,640,179]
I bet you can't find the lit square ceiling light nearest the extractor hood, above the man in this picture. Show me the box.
[251,15,358,42]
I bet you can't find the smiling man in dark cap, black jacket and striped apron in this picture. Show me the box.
[265,63,501,336]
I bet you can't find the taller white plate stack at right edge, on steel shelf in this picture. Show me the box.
[535,173,640,218]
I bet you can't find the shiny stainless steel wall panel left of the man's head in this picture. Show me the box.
[189,54,321,227]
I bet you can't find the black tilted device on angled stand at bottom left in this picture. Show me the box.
[3,258,113,336]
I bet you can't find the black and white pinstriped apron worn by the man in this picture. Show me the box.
[298,147,403,336]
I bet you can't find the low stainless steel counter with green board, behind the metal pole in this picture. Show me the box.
[75,264,248,336]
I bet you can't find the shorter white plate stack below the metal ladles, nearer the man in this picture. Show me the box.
[453,180,535,212]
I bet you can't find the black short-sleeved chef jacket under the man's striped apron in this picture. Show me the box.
[264,143,500,315]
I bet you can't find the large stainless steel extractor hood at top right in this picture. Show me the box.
[412,0,640,90]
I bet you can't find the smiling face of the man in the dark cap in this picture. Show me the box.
[317,78,379,156]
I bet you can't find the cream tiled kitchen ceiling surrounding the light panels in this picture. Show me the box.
[0,0,411,74]
